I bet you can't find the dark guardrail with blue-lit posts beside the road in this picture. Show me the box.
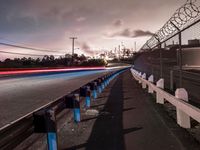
[0,68,128,150]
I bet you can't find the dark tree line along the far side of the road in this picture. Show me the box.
[0,54,106,68]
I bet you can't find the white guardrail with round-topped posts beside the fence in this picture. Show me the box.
[131,68,200,128]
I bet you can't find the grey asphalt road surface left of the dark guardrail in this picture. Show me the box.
[0,69,122,127]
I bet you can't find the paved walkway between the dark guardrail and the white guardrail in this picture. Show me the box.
[59,71,197,150]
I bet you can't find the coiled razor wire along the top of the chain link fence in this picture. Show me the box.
[141,0,200,50]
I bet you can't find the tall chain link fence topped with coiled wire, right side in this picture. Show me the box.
[134,0,200,104]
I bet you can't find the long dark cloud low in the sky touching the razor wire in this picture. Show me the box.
[107,28,154,38]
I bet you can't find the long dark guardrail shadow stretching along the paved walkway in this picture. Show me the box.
[65,75,142,150]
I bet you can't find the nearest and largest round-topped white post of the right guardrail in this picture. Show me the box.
[175,88,191,128]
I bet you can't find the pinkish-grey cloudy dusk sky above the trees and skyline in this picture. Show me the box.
[0,0,186,59]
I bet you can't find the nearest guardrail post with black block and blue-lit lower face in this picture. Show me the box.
[33,109,58,150]
